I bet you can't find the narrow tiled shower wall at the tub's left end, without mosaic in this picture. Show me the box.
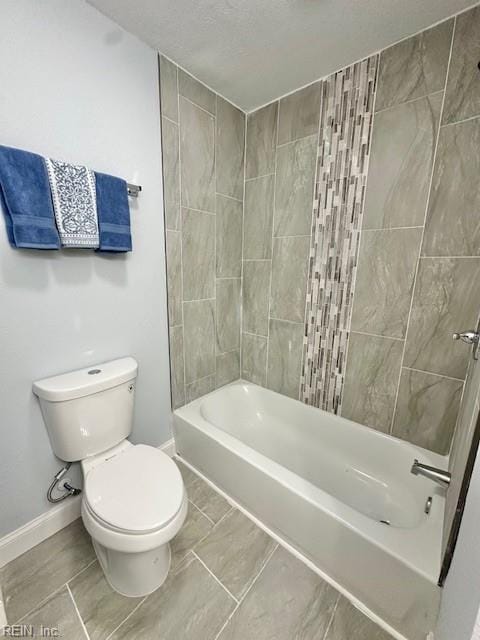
[159,57,245,408]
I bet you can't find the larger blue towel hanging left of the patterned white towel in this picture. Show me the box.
[0,145,60,249]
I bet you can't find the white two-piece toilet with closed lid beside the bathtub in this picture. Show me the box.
[33,358,187,597]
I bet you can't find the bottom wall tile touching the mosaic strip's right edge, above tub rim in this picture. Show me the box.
[341,333,403,433]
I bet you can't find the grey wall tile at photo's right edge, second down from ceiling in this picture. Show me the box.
[422,116,480,256]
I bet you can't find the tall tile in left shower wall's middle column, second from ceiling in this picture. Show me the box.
[180,97,215,212]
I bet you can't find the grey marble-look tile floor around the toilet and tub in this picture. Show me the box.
[0,461,391,640]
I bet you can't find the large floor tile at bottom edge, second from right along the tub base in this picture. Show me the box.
[219,547,340,640]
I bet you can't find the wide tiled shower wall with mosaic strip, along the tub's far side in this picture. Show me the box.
[242,8,480,453]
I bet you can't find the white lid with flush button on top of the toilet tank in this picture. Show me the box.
[33,357,138,402]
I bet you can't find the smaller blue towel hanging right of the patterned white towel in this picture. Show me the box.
[95,173,132,251]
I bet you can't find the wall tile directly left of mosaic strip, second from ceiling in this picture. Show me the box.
[274,135,317,236]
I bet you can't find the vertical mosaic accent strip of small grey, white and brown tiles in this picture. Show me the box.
[300,55,378,413]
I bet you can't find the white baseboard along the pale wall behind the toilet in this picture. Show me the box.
[0,438,175,568]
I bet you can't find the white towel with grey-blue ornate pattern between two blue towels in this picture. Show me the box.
[45,158,99,249]
